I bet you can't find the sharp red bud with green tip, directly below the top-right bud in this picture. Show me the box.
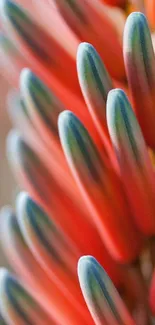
[107,89,155,235]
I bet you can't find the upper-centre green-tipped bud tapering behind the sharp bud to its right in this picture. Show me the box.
[77,43,116,166]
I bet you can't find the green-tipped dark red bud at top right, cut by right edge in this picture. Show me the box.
[124,13,155,148]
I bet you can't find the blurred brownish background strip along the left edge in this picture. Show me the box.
[0,76,16,266]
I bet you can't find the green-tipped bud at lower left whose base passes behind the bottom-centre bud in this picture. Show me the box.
[17,193,94,322]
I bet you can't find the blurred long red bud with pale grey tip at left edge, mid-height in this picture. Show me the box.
[8,133,122,283]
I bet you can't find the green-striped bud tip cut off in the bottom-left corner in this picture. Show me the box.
[0,269,54,325]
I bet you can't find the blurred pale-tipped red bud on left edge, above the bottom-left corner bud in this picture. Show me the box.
[0,207,89,325]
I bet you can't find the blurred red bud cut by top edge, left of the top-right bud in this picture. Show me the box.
[54,0,125,80]
